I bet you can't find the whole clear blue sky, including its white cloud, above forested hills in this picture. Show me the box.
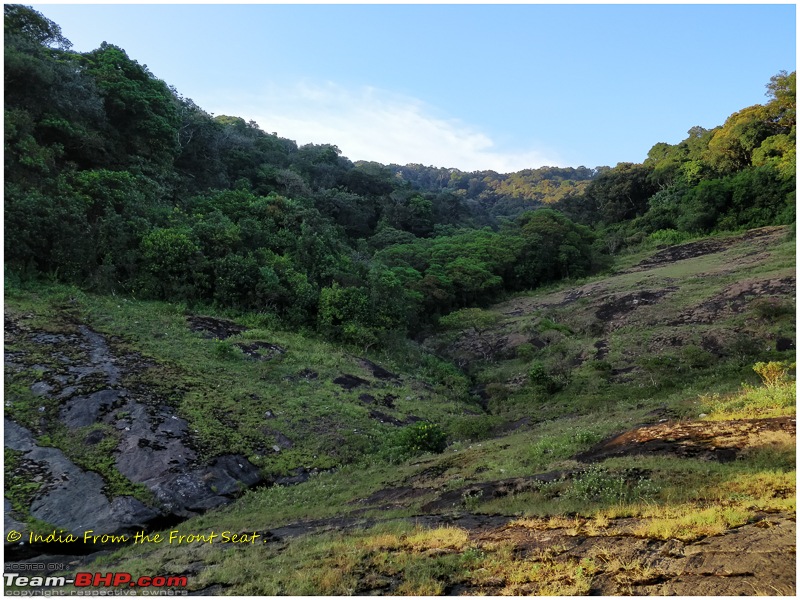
[32,4,796,172]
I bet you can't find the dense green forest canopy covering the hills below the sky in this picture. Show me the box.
[4,5,796,345]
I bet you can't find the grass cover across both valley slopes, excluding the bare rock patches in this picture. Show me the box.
[8,226,795,595]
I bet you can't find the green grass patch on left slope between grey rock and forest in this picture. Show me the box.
[6,285,472,475]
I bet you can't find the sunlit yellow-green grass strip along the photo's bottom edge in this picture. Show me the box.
[178,523,592,596]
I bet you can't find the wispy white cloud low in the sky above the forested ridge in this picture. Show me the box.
[210,82,564,173]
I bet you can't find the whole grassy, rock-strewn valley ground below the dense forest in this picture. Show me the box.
[5,227,796,595]
